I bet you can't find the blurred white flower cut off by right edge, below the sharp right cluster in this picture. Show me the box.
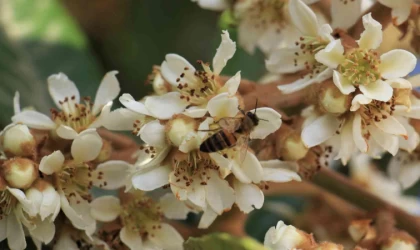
[388,151,420,189]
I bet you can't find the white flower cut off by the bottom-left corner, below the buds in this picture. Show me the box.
[0,187,38,250]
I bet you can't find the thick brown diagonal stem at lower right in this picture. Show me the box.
[311,168,420,241]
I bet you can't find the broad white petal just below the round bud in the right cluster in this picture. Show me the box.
[301,114,340,148]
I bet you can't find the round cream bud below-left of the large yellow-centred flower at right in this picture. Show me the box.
[318,82,352,115]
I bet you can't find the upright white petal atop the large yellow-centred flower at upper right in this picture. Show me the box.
[357,13,382,49]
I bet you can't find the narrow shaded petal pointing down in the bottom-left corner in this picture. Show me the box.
[7,213,26,249]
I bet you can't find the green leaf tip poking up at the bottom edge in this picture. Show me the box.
[184,233,266,250]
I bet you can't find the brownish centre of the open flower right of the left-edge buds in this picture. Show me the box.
[56,161,93,200]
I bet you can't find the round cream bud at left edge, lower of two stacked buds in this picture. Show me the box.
[1,158,38,189]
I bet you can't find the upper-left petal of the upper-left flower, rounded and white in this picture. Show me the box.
[48,73,80,109]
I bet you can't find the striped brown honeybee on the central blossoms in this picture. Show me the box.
[200,107,260,153]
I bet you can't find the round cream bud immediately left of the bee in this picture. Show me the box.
[165,114,198,147]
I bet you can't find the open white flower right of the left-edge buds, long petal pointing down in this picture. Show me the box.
[39,145,126,234]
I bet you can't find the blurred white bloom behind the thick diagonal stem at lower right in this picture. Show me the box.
[349,154,420,215]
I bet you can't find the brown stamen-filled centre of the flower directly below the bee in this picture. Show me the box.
[172,150,220,187]
